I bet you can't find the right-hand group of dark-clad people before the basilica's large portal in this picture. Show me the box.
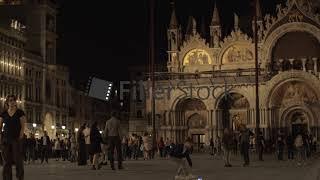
[210,125,318,167]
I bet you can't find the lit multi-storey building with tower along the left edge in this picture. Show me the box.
[0,0,70,138]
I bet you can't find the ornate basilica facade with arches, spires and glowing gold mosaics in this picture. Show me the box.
[142,0,320,146]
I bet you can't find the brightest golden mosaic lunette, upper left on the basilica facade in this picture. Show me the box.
[183,49,212,66]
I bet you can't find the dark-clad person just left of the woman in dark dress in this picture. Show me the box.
[77,124,87,166]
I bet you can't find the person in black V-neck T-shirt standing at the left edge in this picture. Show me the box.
[0,95,26,180]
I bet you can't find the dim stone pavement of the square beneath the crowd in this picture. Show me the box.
[1,154,320,180]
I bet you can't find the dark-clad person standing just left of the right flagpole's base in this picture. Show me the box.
[240,125,254,166]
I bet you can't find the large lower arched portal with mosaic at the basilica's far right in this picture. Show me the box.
[267,77,320,134]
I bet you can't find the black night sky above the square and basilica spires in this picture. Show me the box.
[57,0,282,87]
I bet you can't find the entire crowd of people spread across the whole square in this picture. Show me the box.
[0,95,317,180]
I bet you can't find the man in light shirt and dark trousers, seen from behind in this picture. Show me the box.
[104,111,123,170]
